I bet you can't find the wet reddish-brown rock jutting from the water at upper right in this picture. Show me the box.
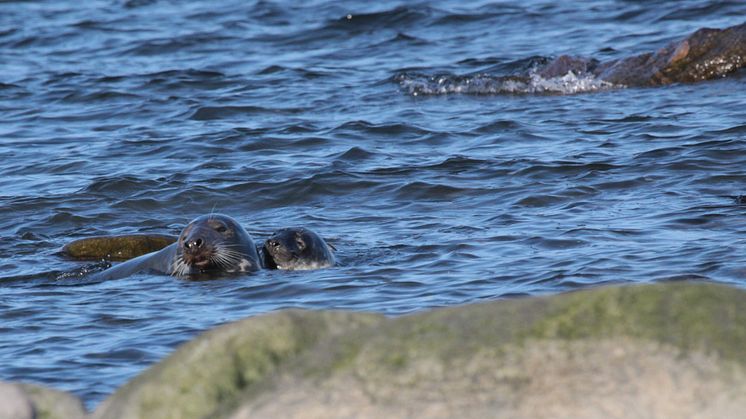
[539,23,746,86]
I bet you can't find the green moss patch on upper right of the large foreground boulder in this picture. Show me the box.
[525,283,746,363]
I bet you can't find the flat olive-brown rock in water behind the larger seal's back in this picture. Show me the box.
[62,234,176,260]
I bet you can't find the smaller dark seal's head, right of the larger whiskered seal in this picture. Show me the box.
[262,227,336,271]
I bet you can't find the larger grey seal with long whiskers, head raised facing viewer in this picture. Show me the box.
[94,214,260,280]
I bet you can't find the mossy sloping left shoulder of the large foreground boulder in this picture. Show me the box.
[93,310,382,419]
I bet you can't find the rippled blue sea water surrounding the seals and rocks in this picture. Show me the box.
[0,0,746,407]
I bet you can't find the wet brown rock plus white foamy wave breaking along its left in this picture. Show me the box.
[402,23,746,96]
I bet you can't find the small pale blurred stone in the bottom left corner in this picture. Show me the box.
[0,382,86,419]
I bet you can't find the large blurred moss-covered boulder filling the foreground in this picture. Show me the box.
[93,282,746,418]
